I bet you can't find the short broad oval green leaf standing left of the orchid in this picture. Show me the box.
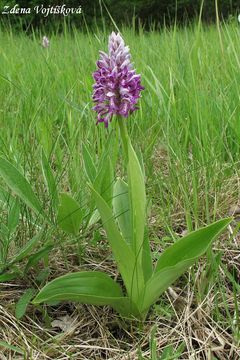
[57,193,82,235]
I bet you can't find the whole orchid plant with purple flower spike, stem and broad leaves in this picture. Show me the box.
[33,33,231,320]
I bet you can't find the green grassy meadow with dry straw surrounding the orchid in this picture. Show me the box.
[0,23,240,360]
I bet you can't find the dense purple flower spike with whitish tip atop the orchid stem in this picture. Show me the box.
[93,32,144,127]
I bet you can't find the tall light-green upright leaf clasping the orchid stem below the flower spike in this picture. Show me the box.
[128,141,146,264]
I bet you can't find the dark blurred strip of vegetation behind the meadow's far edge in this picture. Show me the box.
[0,0,240,31]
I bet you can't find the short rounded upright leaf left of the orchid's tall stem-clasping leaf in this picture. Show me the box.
[112,179,132,244]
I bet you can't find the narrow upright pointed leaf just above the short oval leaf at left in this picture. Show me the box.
[41,149,58,208]
